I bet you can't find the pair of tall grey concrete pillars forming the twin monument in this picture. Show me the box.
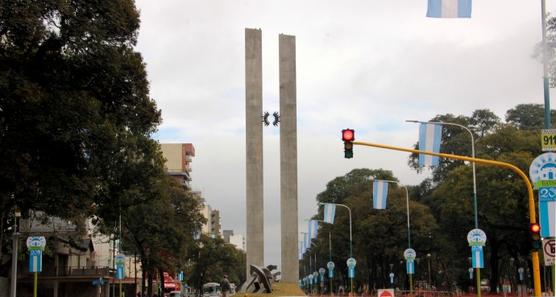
[245,29,299,283]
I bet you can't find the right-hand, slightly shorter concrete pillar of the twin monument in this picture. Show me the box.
[278,34,299,283]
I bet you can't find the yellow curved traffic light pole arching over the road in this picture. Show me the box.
[353,141,541,297]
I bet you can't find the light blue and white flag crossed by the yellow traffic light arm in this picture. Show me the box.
[419,123,442,167]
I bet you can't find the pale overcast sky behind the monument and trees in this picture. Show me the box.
[137,0,556,265]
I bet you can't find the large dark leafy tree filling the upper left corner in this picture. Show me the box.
[0,0,162,266]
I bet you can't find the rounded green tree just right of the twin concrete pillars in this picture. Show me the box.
[306,169,438,288]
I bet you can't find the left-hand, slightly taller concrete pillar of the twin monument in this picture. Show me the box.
[245,29,264,275]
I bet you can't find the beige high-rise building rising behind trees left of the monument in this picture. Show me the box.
[160,143,195,189]
